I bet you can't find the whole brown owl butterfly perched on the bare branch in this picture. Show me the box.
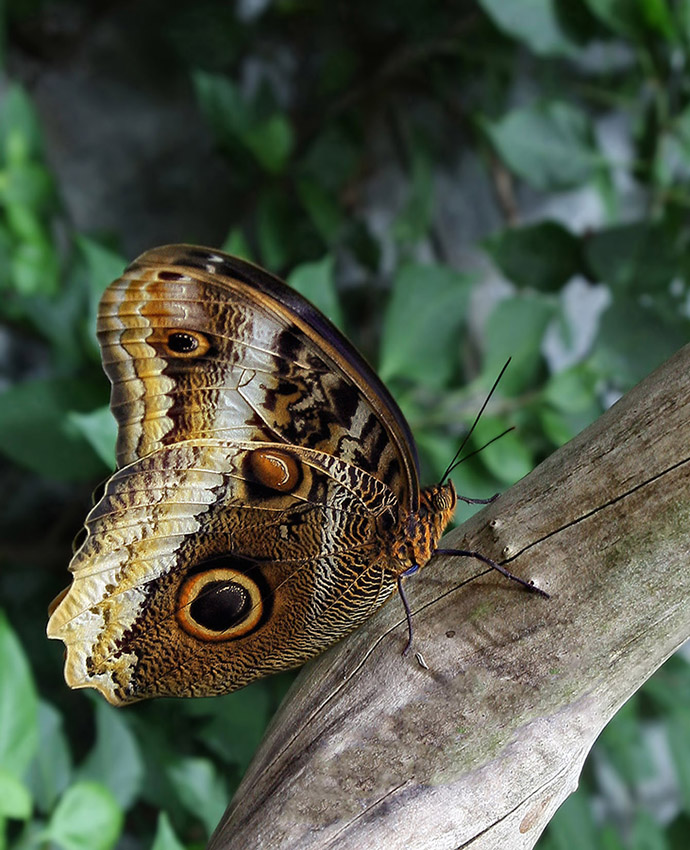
[48,245,544,705]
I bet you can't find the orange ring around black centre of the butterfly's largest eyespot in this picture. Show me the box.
[175,567,263,642]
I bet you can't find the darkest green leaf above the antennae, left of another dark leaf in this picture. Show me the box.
[484,221,582,292]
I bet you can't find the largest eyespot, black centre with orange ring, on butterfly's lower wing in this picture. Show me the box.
[177,567,264,641]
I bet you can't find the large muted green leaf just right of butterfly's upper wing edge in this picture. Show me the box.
[379,265,474,387]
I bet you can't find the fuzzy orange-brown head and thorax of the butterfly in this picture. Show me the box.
[391,481,458,575]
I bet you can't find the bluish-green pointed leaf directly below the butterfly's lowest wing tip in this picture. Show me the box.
[79,700,144,811]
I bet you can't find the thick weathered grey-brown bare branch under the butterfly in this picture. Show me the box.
[209,346,690,850]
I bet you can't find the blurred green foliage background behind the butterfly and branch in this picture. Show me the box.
[0,0,690,850]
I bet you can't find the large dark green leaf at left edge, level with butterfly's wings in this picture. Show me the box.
[0,378,109,481]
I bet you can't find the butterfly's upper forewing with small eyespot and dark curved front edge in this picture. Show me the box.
[98,245,419,512]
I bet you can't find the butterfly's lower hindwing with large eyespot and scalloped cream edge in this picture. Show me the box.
[48,439,399,705]
